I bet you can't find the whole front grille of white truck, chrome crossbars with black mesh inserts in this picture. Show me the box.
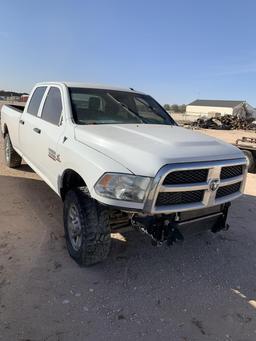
[151,159,246,214]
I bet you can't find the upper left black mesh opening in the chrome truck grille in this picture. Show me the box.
[163,169,208,185]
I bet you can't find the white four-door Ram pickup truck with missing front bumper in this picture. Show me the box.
[1,82,247,265]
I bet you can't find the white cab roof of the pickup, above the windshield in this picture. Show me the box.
[36,82,143,94]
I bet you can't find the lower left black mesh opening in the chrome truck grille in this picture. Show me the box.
[156,191,204,206]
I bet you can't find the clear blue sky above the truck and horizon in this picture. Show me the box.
[0,0,256,106]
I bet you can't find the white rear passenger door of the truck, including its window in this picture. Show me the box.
[19,86,47,170]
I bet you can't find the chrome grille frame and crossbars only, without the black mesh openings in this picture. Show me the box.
[143,158,247,214]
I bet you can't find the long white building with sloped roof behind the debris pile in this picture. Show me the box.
[186,99,249,116]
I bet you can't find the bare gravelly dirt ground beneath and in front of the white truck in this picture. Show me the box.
[0,131,256,341]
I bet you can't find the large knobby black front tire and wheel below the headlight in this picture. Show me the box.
[63,188,111,266]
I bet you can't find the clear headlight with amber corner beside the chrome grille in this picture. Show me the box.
[95,173,151,202]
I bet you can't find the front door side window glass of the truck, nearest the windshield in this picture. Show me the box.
[41,87,62,125]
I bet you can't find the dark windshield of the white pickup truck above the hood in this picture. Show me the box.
[69,88,175,125]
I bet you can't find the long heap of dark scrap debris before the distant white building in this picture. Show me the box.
[192,115,256,130]
